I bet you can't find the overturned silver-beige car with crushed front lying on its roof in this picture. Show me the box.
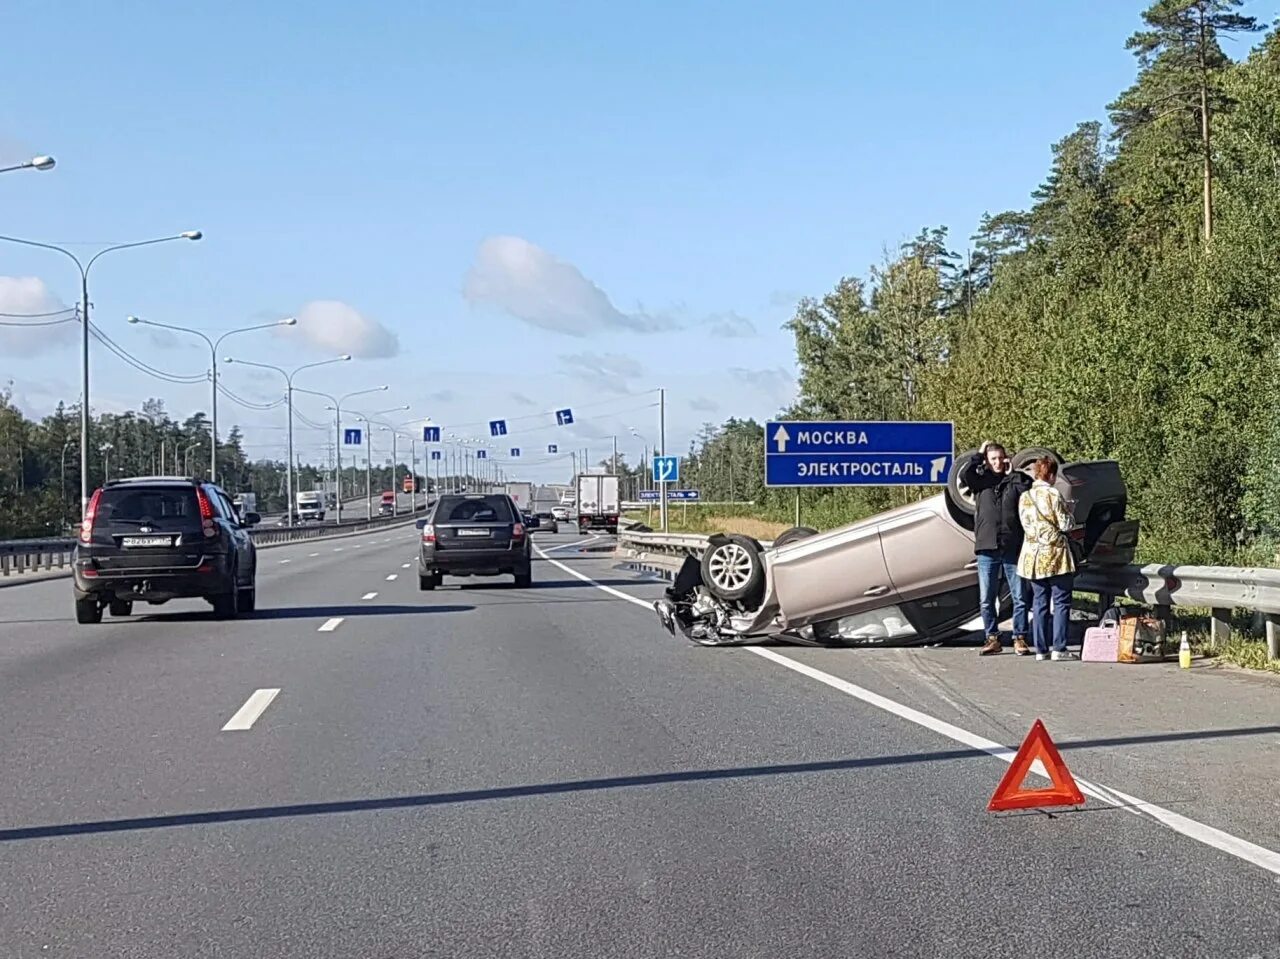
[654,447,1138,645]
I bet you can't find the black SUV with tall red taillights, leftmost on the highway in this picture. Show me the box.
[72,476,261,622]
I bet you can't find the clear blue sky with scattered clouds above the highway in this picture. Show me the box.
[0,0,1275,480]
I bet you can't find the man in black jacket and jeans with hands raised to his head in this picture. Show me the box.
[959,440,1032,656]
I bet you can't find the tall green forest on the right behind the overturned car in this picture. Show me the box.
[689,0,1280,566]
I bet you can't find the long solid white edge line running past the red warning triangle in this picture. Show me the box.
[538,548,1280,876]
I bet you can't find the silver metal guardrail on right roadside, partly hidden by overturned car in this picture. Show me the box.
[618,530,1280,659]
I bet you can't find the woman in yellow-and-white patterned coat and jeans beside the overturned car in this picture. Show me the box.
[1018,456,1079,659]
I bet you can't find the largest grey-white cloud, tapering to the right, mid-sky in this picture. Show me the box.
[462,237,675,337]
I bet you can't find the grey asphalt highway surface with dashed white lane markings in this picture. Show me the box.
[0,529,1280,959]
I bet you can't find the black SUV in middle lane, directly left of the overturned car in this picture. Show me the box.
[417,493,534,589]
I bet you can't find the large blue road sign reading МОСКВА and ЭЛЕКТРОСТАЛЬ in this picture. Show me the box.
[764,423,955,487]
